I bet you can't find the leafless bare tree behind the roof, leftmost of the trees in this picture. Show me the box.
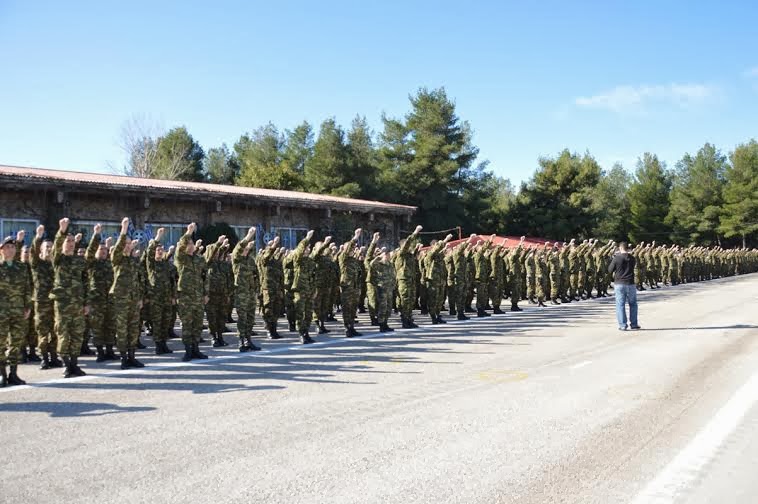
[118,115,163,178]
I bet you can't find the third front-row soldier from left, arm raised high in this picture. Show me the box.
[109,217,145,369]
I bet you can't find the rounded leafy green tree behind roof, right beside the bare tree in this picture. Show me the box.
[151,126,205,182]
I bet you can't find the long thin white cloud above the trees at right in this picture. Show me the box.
[574,83,717,114]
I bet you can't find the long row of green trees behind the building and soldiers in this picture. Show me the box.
[121,88,758,250]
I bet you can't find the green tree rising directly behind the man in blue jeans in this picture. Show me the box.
[592,163,632,241]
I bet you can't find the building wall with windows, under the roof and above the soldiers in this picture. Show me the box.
[0,187,406,246]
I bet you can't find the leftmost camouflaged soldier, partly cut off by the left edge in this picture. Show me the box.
[0,235,32,387]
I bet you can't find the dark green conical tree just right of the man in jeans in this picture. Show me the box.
[629,152,671,243]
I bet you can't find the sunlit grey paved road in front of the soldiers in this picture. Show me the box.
[0,275,758,504]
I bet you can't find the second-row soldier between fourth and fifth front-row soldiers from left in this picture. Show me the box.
[205,235,229,348]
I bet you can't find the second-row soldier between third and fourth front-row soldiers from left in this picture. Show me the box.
[145,228,176,355]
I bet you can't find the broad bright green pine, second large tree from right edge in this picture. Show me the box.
[665,143,727,245]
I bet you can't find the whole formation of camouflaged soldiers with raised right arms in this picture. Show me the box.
[0,218,758,386]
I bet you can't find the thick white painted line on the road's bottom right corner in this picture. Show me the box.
[632,373,758,504]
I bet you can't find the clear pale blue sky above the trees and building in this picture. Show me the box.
[0,0,758,183]
